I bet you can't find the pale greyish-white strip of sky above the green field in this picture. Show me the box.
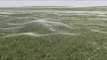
[0,0,107,7]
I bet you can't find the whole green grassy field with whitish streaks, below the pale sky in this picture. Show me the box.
[0,7,107,60]
